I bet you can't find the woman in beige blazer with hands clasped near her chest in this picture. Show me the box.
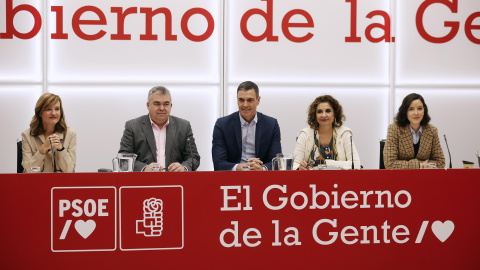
[22,93,77,173]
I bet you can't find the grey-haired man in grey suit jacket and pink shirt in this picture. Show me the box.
[118,86,200,172]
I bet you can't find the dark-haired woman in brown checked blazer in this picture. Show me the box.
[383,93,445,169]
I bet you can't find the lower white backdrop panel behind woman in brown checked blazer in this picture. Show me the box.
[395,88,480,168]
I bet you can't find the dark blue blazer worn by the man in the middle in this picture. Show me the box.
[212,111,282,171]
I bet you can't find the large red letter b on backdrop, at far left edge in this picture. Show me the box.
[0,0,42,39]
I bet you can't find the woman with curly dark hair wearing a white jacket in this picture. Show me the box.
[293,95,360,170]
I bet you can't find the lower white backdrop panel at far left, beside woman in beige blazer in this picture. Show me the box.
[0,85,43,173]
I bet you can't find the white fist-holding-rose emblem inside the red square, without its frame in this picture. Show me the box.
[137,198,163,237]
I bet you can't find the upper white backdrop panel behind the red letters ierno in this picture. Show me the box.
[48,0,221,83]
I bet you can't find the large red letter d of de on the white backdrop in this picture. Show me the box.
[240,0,278,42]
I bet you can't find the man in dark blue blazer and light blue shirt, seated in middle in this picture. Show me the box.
[212,81,282,171]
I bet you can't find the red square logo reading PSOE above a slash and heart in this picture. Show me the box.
[51,187,117,252]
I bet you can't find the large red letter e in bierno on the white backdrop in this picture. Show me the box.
[72,6,107,40]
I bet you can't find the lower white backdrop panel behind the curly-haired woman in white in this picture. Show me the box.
[227,84,388,169]
